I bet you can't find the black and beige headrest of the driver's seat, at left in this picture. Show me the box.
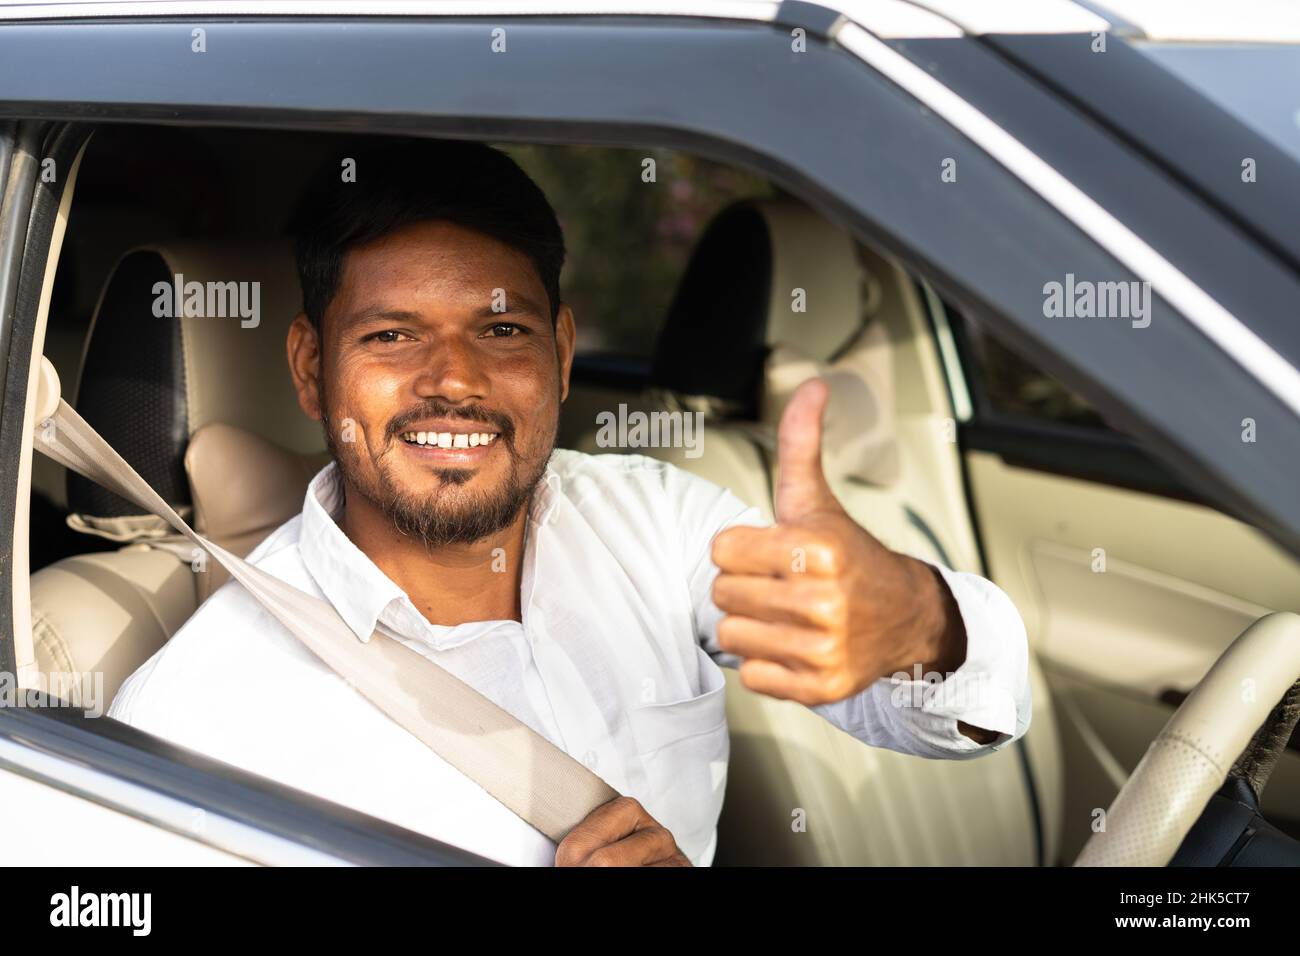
[68,241,324,522]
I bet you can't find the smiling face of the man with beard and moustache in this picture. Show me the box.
[289,221,573,546]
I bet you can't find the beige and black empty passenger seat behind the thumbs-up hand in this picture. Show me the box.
[573,199,1062,865]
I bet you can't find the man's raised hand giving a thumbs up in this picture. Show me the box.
[712,378,966,706]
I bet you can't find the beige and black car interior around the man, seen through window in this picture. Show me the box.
[17,126,1300,865]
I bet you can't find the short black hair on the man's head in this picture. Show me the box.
[289,139,564,333]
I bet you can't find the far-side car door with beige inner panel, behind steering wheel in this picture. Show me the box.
[946,303,1300,858]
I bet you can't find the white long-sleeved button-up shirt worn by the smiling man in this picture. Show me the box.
[109,450,1030,865]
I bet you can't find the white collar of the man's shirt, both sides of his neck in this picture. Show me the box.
[298,462,562,643]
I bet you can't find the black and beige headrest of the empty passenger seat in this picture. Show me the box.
[650,198,865,418]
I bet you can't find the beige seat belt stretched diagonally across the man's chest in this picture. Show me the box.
[33,356,619,843]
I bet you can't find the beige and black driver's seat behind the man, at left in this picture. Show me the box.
[31,242,328,709]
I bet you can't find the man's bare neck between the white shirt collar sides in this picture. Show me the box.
[338,486,528,627]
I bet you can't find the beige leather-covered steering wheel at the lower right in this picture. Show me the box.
[1074,611,1300,866]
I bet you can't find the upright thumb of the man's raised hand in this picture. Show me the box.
[776,378,840,522]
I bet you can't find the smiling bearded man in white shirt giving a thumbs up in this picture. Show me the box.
[109,140,1030,865]
